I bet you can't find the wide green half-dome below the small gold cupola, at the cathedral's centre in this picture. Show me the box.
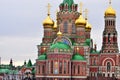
[50,42,71,49]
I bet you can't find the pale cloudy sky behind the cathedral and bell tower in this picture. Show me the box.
[0,0,120,65]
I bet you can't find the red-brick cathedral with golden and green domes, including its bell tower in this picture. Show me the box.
[36,0,120,80]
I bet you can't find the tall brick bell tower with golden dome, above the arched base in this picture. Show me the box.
[102,1,119,53]
